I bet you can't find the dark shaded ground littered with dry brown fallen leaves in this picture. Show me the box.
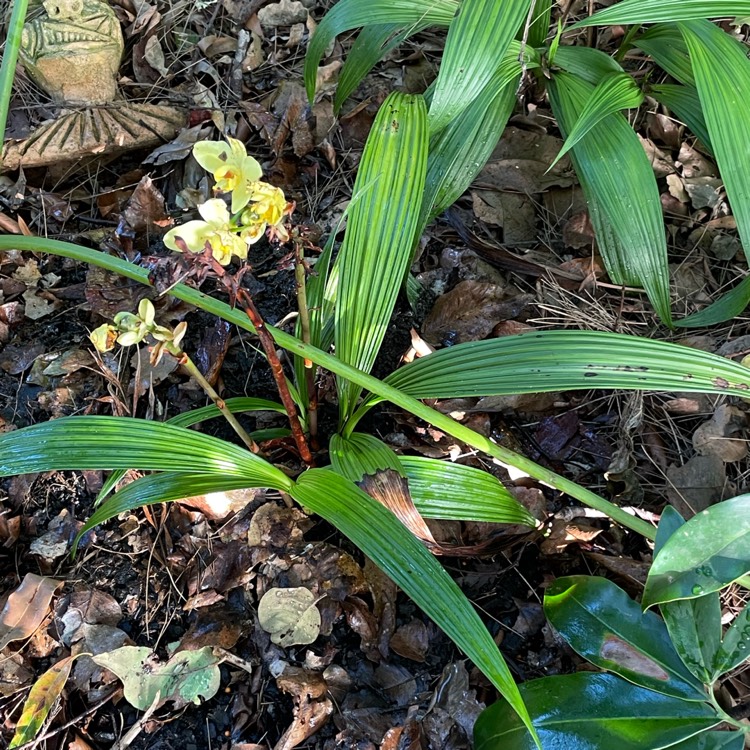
[0,0,750,750]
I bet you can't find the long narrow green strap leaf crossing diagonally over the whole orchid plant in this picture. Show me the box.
[0,235,655,539]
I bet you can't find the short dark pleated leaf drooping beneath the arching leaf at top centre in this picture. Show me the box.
[333,23,426,114]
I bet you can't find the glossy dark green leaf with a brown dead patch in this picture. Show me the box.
[544,576,706,701]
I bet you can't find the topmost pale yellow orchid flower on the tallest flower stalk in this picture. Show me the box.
[193,138,263,214]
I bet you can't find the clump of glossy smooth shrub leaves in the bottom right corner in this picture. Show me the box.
[475,495,750,750]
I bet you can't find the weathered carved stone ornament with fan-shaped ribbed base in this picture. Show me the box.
[0,0,185,171]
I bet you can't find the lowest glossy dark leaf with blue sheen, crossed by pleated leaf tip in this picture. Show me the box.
[474,672,720,750]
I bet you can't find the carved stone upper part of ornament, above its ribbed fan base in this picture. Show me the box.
[21,0,125,104]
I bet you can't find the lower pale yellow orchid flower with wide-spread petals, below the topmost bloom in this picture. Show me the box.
[164,198,249,266]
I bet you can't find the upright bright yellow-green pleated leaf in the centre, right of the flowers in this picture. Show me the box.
[335,93,427,423]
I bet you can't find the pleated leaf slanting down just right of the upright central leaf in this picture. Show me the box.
[420,50,521,227]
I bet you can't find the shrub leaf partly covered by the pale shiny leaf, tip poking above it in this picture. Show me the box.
[654,505,721,684]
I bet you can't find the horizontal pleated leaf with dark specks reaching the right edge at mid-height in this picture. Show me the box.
[370,331,750,402]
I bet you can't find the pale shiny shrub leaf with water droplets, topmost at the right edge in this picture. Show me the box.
[643,495,750,607]
